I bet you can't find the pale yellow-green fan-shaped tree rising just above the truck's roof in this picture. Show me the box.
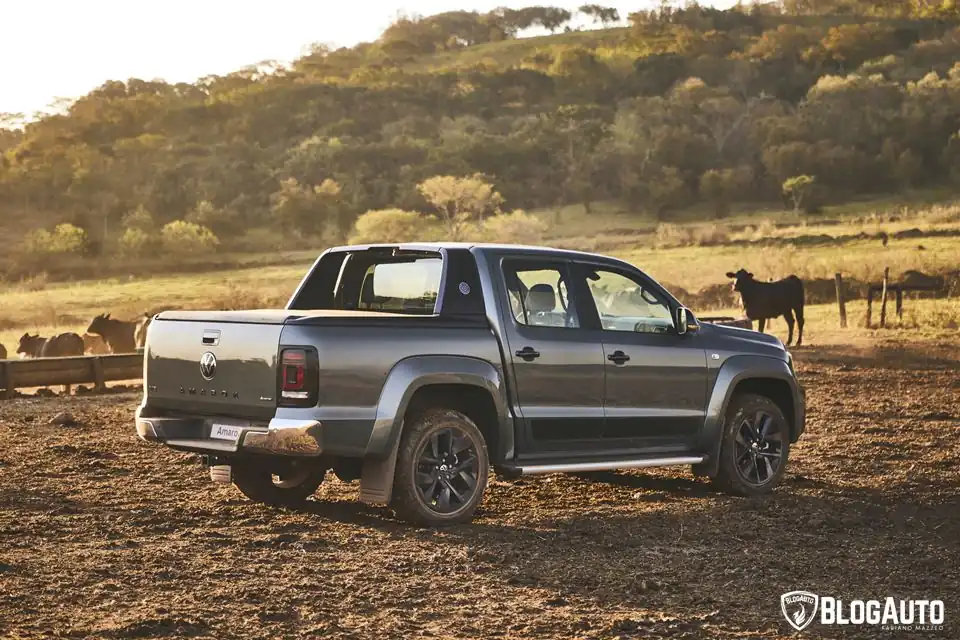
[417,175,503,241]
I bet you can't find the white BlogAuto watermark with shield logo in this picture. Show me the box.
[780,591,945,631]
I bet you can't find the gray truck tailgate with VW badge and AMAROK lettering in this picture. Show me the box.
[144,311,290,420]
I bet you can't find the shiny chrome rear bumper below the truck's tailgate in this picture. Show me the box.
[136,409,324,457]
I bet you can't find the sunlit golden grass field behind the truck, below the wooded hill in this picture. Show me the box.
[0,194,960,351]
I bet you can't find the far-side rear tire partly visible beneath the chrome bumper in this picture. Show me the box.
[231,462,326,507]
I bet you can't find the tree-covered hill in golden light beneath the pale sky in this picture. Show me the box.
[0,0,960,277]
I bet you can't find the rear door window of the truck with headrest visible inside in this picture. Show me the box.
[503,260,580,329]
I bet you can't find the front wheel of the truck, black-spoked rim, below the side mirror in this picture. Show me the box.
[713,394,790,496]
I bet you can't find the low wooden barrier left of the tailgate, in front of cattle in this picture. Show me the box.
[0,353,143,398]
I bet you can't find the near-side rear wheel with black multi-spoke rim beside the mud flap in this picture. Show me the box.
[390,409,490,526]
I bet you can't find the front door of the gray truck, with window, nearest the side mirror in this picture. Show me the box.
[580,265,707,451]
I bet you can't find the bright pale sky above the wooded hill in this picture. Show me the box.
[0,0,736,117]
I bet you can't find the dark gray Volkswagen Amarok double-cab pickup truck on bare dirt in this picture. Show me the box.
[136,243,805,525]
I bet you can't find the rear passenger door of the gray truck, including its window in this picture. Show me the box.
[500,257,605,456]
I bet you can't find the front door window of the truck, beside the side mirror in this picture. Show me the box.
[587,269,673,333]
